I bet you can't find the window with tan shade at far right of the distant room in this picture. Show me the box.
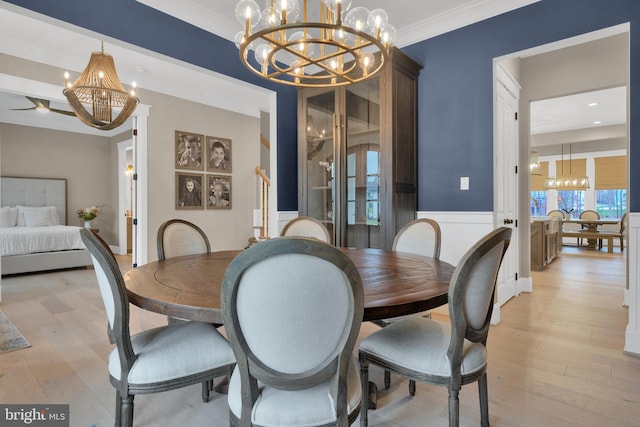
[594,156,627,219]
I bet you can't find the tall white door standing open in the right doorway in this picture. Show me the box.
[494,65,528,310]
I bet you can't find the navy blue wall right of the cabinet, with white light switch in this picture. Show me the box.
[404,0,640,211]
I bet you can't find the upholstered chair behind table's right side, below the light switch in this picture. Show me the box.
[372,218,442,396]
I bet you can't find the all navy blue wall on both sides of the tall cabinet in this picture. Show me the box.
[9,0,640,212]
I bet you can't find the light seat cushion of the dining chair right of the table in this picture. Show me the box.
[360,316,487,377]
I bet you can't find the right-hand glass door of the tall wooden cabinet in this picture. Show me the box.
[338,79,382,248]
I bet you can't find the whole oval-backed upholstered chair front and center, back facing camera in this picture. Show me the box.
[222,237,364,427]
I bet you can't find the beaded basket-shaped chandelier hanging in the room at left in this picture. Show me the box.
[62,43,138,130]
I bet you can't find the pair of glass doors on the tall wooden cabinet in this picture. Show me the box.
[300,78,382,248]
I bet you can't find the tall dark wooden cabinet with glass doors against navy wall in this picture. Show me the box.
[298,48,421,249]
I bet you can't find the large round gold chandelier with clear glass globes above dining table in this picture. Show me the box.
[235,0,397,87]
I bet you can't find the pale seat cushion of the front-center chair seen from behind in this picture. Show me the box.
[228,358,362,427]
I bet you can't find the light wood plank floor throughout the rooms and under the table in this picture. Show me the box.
[0,248,640,427]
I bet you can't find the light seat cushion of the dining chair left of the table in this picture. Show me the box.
[109,322,235,384]
